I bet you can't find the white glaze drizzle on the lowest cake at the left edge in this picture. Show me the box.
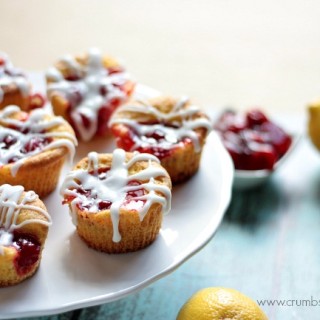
[0,184,51,254]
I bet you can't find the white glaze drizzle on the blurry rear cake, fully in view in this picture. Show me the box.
[46,48,130,141]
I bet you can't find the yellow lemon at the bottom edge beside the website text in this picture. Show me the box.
[177,287,268,320]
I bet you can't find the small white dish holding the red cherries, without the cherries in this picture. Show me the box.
[233,134,301,190]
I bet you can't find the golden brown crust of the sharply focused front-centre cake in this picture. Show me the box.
[63,153,171,253]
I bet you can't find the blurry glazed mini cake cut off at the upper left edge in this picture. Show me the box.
[0,52,45,111]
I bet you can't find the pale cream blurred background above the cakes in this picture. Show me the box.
[0,0,320,113]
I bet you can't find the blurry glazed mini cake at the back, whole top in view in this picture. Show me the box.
[46,49,134,141]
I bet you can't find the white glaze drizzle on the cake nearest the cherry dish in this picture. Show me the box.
[109,97,212,152]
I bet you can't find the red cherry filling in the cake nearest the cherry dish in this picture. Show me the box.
[111,124,192,160]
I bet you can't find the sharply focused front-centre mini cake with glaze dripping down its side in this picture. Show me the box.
[61,149,171,253]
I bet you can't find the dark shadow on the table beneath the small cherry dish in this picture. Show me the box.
[224,180,281,229]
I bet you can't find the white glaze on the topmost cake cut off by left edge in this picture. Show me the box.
[0,52,30,103]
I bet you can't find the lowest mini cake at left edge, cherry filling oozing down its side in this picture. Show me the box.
[0,184,51,287]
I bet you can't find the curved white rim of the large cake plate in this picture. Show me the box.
[0,78,234,319]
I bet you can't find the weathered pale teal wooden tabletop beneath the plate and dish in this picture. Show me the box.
[15,121,320,320]
